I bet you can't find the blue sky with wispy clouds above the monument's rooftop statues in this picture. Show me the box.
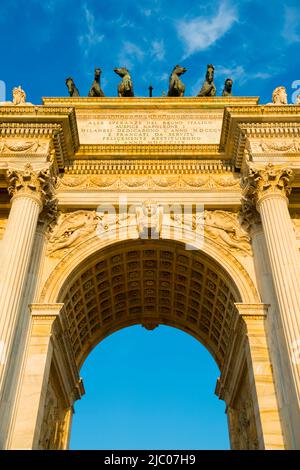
[0,0,300,103]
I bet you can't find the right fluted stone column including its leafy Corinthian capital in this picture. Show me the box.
[246,164,300,428]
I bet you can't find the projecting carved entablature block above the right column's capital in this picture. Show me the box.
[219,105,300,174]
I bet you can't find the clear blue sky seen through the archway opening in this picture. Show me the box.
[70,325,229,450]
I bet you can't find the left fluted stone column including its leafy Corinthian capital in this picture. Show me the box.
[0,163,53,400]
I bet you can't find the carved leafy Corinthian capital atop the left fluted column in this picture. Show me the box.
[7,163,56,210]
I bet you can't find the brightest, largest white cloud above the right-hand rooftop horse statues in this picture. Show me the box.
[176,0,238,59]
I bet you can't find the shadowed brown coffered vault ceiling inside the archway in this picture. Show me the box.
[58,240,241,369]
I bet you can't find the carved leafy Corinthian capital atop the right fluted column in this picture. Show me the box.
[244,163,293,210]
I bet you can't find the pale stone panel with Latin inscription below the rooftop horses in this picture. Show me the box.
[77,112,223,145]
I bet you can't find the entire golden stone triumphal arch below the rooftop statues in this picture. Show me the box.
[0,96,300,449]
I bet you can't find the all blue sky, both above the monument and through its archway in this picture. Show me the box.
[0,0,300,449]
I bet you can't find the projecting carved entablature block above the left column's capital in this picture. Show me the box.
[0,105,79,172]
